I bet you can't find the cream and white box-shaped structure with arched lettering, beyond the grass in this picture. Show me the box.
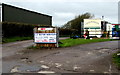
[83,19,113,38]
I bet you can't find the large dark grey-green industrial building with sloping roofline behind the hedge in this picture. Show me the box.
[0,3,52,26]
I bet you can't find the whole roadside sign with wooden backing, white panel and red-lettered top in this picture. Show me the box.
[34,28,59,47]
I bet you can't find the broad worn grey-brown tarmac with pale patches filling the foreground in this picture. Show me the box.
[2,40,120,73]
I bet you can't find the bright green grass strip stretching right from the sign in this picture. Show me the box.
[59,39,112,47]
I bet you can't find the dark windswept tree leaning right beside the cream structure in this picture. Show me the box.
[62,13,94,36]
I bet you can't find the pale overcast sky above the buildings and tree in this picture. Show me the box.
[0,0,119,26]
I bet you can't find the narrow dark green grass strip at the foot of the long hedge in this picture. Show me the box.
[2,37,33,43]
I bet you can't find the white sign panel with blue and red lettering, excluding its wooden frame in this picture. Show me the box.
[34,33,56,43]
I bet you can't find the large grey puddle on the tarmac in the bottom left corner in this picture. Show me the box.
[2,61,44,73]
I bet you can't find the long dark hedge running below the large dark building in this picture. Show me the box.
[2,22,51,37]
